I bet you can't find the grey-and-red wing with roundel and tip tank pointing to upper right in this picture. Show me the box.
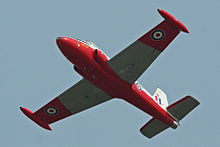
[108,9,188,84]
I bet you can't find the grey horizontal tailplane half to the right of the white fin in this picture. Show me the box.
[167,96,200,120]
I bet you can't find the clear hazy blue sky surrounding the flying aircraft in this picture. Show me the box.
[0,0,220,147]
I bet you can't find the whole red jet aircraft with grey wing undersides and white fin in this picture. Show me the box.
[20,9,199,138]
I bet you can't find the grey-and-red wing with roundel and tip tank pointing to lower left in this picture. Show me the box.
[21,79,112,130]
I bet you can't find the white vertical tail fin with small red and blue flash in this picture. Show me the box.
[153,88,168,109]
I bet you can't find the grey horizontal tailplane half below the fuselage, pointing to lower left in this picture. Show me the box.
[140,118,169,138]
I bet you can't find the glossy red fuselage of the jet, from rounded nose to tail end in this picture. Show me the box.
[57,37,177,127]
